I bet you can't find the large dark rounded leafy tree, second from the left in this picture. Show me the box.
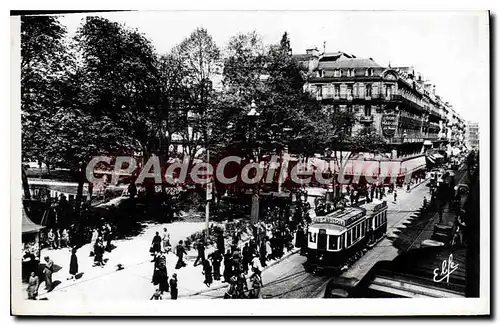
[76,17,160,157]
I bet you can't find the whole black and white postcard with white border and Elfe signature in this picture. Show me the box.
[10,10,491,316]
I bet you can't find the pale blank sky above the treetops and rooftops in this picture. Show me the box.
[55,11,489,121]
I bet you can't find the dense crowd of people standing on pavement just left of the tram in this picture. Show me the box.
[144,221,305,300]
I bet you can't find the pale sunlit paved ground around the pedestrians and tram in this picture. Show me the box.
[23,172,470,302]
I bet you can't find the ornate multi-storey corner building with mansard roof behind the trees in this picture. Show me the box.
[295,49,460,157]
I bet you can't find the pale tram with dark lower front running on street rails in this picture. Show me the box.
[304,200,387,272]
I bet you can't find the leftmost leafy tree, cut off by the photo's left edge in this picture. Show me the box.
[21,16,71,168]
